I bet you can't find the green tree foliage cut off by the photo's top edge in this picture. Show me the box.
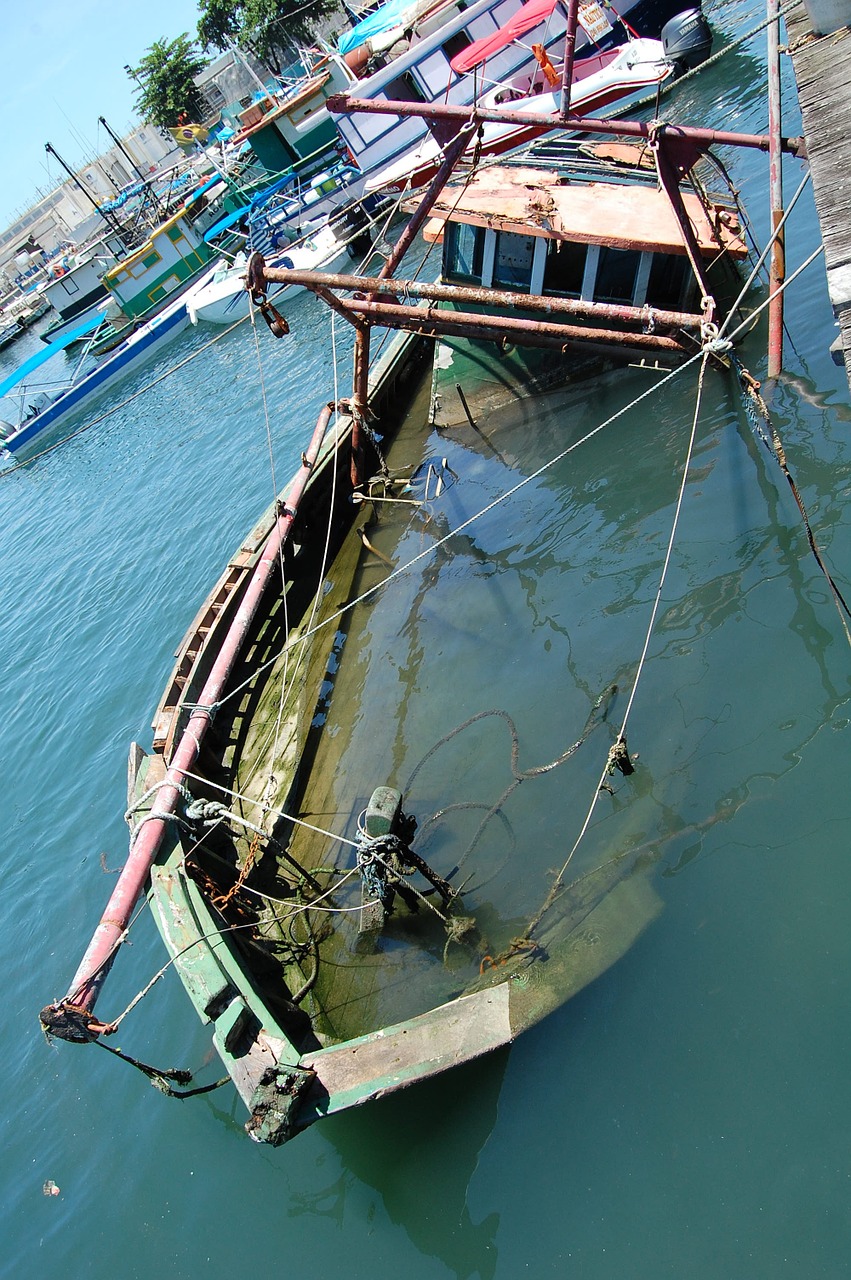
[198,0,337,72]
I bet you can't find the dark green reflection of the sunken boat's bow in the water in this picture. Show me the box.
[289,1050,509,1280]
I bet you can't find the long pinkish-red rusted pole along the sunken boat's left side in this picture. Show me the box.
[45,404,334,1036]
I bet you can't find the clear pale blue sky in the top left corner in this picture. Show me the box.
[0,0,206,228]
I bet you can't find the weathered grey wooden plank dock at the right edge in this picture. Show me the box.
[786,3,851,384]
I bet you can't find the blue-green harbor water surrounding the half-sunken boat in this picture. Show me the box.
[0,0,851,1280]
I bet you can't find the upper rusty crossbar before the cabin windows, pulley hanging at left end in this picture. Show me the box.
[257,266,701,329]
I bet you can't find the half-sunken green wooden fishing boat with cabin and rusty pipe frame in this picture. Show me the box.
[42,0,834,1142]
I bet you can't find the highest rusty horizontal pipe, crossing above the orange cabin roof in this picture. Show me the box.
[325,93,806,156]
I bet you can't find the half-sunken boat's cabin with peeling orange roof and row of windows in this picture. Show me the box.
[426,146,747,426]
